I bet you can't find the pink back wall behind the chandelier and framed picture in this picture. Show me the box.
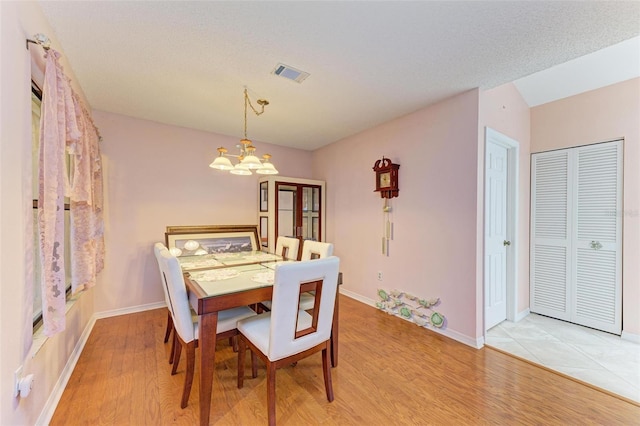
[93,111,311,312]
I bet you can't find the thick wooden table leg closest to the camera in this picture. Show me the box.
[198,312,218,426]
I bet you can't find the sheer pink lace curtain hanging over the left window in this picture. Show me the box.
[38,49,104,336]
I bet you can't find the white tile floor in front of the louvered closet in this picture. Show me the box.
[486,314,640,403]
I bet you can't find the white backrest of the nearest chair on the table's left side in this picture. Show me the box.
[160,248,196,343]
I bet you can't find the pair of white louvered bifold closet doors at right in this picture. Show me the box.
[531,141,622,334]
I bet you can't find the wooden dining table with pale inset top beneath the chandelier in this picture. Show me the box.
[178,251,342,425]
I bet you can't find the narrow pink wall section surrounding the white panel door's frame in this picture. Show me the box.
[478,83,531,318]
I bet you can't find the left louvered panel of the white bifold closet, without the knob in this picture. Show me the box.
[530,151,571,320]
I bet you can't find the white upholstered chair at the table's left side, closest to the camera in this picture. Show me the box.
[154,246,257,408]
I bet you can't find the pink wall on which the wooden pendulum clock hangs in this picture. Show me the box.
[313,90,481,345]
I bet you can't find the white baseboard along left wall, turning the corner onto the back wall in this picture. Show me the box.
[36,302,167,426]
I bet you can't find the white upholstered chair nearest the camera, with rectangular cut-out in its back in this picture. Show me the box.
[238,256,340,425]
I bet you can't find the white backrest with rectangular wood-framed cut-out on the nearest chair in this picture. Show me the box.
[267,256,340,361]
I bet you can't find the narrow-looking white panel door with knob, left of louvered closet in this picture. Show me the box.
[484,141,510,330]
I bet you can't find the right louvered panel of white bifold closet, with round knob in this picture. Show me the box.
[572,141,622,334]
